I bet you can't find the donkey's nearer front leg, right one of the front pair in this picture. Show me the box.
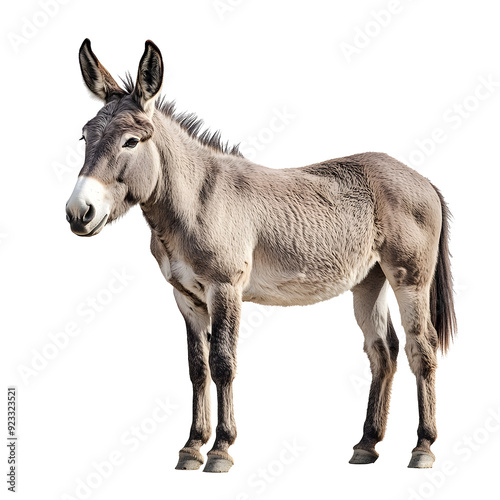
[204,283,241,472]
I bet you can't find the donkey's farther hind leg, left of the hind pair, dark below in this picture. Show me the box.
[349,264,399,464]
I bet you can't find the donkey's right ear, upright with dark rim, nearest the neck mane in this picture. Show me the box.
[132,40,163,115]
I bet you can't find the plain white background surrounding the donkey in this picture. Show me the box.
[0,0,500,500]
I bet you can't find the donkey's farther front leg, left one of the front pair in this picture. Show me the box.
[174,290,211,470]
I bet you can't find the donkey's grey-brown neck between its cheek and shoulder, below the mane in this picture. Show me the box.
[141,111,220,237]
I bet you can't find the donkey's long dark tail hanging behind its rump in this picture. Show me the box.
[430,186,457,354]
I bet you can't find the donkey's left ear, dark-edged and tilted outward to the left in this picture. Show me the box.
[79,38,125,102]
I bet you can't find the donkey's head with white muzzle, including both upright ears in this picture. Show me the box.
[66,39,163,236]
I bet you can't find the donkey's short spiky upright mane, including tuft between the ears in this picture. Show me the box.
[121,73,243,156]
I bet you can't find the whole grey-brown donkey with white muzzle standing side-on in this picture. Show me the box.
[66,39,456,472]
